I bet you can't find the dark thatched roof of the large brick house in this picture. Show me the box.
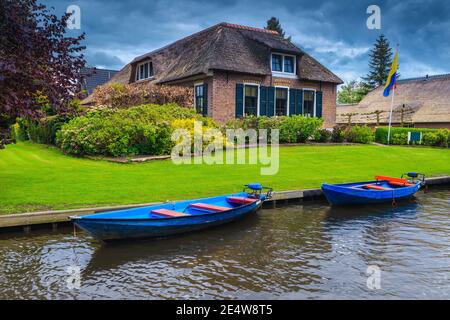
[107,23,342,83]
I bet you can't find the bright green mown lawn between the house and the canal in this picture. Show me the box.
[0,142,450,213]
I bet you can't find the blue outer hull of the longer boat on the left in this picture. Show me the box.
[73,196,262,241]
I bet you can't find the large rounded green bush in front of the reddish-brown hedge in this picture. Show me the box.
[57,104,209,156]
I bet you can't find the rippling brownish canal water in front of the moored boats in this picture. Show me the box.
[0,188,450,299]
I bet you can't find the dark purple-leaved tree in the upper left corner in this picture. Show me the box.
[0,0,85,118]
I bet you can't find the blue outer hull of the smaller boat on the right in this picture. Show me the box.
[322,181,421,205]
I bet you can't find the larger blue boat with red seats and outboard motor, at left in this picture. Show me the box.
[70,183,272,241]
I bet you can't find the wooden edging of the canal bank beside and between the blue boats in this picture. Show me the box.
[0,176,450,232]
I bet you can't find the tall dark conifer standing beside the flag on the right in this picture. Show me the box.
[363,35,392,89]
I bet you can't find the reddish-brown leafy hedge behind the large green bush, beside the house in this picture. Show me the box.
[92,83,194,108]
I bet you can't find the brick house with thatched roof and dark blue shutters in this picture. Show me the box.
[101,23,342,127]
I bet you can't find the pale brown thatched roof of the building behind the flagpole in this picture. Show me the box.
[336,74,450,124]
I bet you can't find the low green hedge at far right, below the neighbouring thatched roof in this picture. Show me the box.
[375,127,450,147]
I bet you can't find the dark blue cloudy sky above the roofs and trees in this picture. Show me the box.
[44,0,450,81]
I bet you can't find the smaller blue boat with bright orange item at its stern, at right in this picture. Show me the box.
[322,172,425,205]
